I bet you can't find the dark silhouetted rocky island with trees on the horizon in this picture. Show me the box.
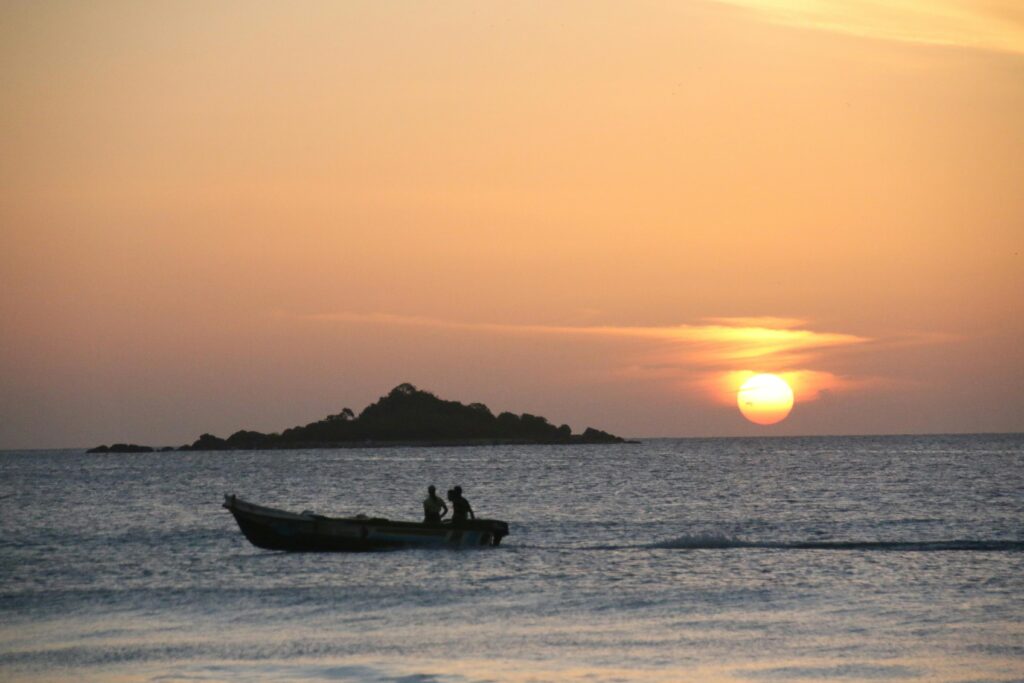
[89,383,627,453]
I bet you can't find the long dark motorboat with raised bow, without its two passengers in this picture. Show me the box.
[224,495,509,552]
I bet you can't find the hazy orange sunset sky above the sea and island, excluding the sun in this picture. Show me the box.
[0,0,1024,449]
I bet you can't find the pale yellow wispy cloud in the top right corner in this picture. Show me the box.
[718,0,1024,54]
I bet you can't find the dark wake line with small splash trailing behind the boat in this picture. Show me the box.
[637,535,1024,553]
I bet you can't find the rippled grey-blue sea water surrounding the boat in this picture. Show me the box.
[0,435,1024,683]
